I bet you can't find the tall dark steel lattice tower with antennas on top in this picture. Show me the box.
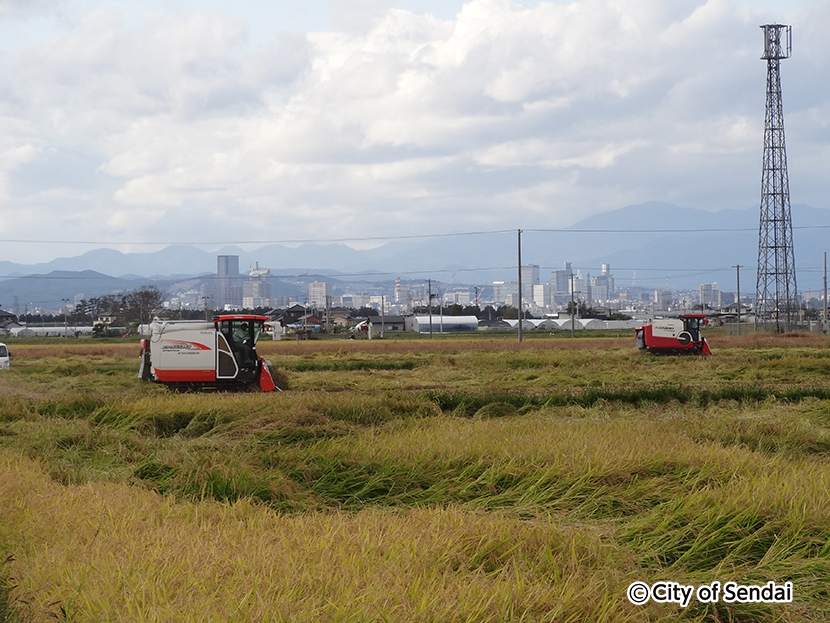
[755,24,798,332]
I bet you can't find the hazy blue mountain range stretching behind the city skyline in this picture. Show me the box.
[0,202,830,294]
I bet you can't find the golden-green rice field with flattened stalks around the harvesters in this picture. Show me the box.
[0,334,830,623]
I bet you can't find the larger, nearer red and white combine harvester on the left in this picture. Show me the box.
[138,314,278,392]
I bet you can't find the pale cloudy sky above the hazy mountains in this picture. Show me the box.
[0,0,830,262]
